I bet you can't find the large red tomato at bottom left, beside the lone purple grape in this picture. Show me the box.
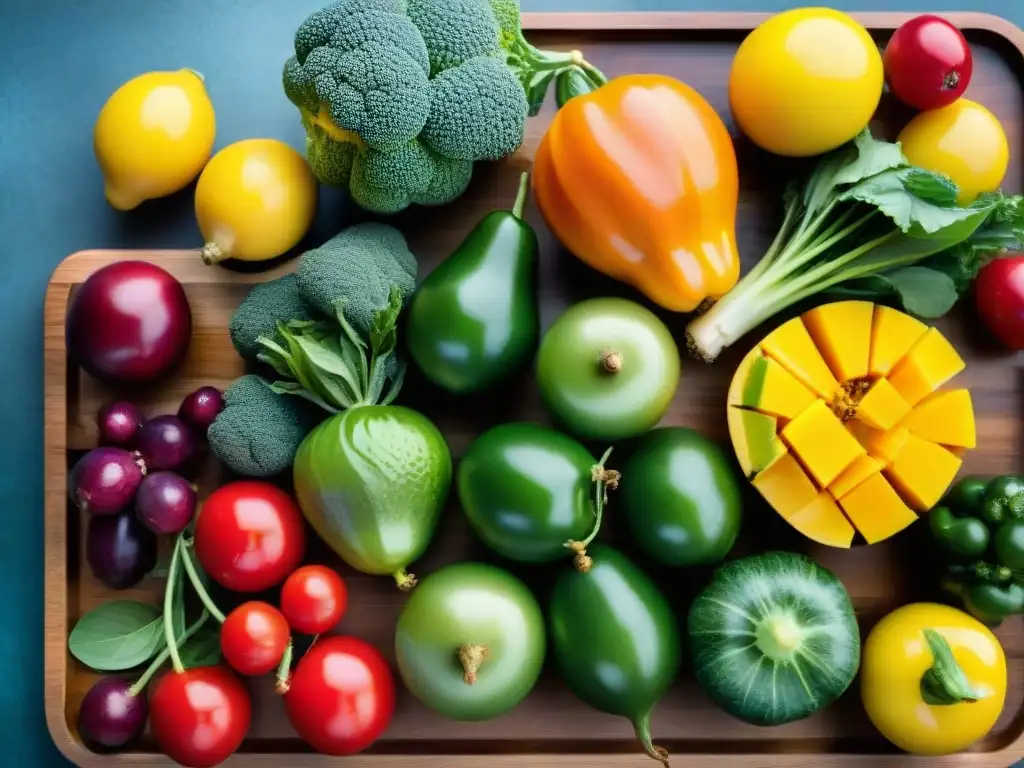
[150,667,252,768]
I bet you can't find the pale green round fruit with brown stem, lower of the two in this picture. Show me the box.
[394,563,546,720]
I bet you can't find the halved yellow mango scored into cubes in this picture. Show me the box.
[727,301,976,547]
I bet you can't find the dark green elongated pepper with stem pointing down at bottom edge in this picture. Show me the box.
[548,545,682,765]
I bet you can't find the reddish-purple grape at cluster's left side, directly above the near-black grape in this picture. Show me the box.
[68,445,146,515]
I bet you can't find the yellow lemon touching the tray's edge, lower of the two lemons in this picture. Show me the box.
[196,138,317,264]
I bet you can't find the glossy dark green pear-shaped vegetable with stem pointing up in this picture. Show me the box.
[406,173,540,394]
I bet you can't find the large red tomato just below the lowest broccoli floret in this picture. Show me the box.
[196,480,306,592]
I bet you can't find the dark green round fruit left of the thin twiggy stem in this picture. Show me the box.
[457,423,599,562]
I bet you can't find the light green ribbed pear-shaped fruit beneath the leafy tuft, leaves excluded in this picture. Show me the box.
[293,406,452,588]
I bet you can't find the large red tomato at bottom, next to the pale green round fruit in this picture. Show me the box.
[285,635,394,756]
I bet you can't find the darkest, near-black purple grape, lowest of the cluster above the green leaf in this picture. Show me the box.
[85,509,157,590]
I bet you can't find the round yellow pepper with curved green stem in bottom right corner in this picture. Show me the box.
[860,603,1007,756]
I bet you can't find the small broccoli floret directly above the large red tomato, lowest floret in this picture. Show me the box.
[206,374,327,477]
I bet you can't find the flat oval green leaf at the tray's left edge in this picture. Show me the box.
[68,600,166,672]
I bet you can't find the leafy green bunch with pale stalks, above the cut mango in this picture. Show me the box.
[686,129,1024,362]
